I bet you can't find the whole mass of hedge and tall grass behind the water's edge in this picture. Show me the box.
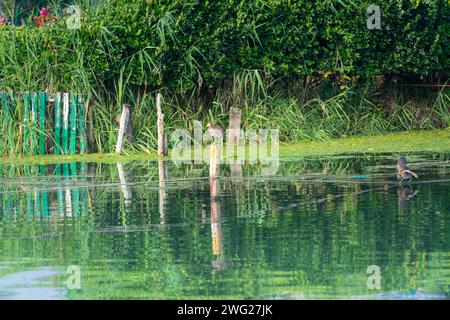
[0,0,450,156]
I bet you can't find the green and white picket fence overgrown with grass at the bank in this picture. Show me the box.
[0,92,88,155]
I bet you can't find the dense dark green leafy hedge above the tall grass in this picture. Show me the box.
[0,0,450,92]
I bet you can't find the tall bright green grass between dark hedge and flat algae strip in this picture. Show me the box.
[0,83,450,155]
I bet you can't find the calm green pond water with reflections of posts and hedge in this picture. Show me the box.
[0,153,450,299]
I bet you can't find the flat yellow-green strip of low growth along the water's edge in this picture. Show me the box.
[0,128,450,165]
